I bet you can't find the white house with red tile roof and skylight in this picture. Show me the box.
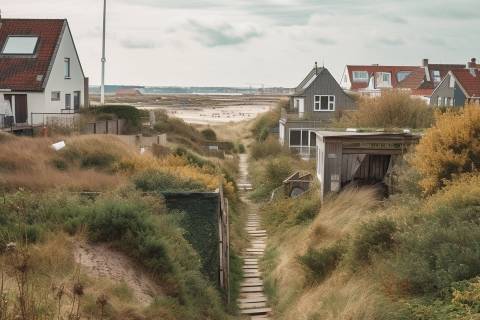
[0,17,88,127]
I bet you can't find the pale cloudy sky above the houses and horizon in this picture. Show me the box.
[0,0,480,87]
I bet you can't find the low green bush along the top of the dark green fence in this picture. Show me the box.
[133,170,206,192]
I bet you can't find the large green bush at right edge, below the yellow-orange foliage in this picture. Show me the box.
[390,206,480,294]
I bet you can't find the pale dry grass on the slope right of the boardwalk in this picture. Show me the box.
[267,188,386,320]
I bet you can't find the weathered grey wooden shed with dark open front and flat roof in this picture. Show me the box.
[315,131,420,199]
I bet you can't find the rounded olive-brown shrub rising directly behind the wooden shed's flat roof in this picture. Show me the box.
[340,91,433,129]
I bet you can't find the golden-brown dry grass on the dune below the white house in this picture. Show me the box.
[0,136,132,191]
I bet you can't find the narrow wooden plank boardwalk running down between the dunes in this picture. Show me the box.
[238,154,272,320]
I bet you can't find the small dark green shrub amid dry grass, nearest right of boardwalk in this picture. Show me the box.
[298,243,345,281]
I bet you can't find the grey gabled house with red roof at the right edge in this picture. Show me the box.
[430,58,480,107]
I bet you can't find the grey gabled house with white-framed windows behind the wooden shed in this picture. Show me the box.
[279,67,355,157]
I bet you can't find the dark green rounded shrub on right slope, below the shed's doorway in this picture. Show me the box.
[351,218,397,264]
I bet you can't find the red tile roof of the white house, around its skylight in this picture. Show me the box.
[0,19,66,91]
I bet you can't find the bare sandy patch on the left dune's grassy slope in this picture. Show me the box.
[74,243,161,305]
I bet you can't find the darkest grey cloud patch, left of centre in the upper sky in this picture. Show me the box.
[188,20,262,47]
